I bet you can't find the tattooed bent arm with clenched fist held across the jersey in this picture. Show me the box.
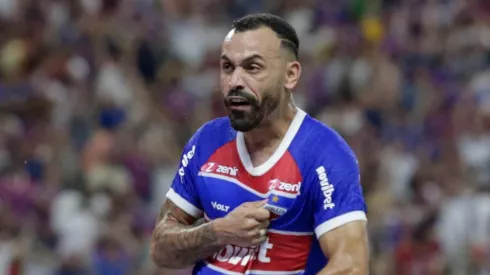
[151,199,270,269]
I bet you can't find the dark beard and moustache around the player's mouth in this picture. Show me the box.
[224,89,279,132]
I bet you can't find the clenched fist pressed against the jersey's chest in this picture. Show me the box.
[213,200,270,247]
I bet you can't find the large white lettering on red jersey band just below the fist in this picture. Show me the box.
[211,239,274,266]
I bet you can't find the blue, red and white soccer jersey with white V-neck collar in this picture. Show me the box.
[167,110,366,275]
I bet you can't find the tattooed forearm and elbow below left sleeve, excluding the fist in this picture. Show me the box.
[151,200,221,268]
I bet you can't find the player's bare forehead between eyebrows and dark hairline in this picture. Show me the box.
[222,27,281,60]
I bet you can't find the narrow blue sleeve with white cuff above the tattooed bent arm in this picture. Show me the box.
[167,131,203,218]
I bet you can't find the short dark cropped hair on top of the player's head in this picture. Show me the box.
[233,13,299,59]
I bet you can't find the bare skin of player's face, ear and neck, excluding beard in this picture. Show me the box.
[220,27,301,162]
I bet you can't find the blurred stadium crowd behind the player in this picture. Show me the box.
[0,0,490,275]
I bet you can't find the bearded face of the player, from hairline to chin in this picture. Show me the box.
[220,27,285,132]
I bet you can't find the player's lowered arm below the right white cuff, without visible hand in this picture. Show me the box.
[318,221,369,275]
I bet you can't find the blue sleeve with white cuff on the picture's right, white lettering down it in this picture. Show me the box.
[309,145,367,238]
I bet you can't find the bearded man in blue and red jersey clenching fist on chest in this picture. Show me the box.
[151,14,369,275]
